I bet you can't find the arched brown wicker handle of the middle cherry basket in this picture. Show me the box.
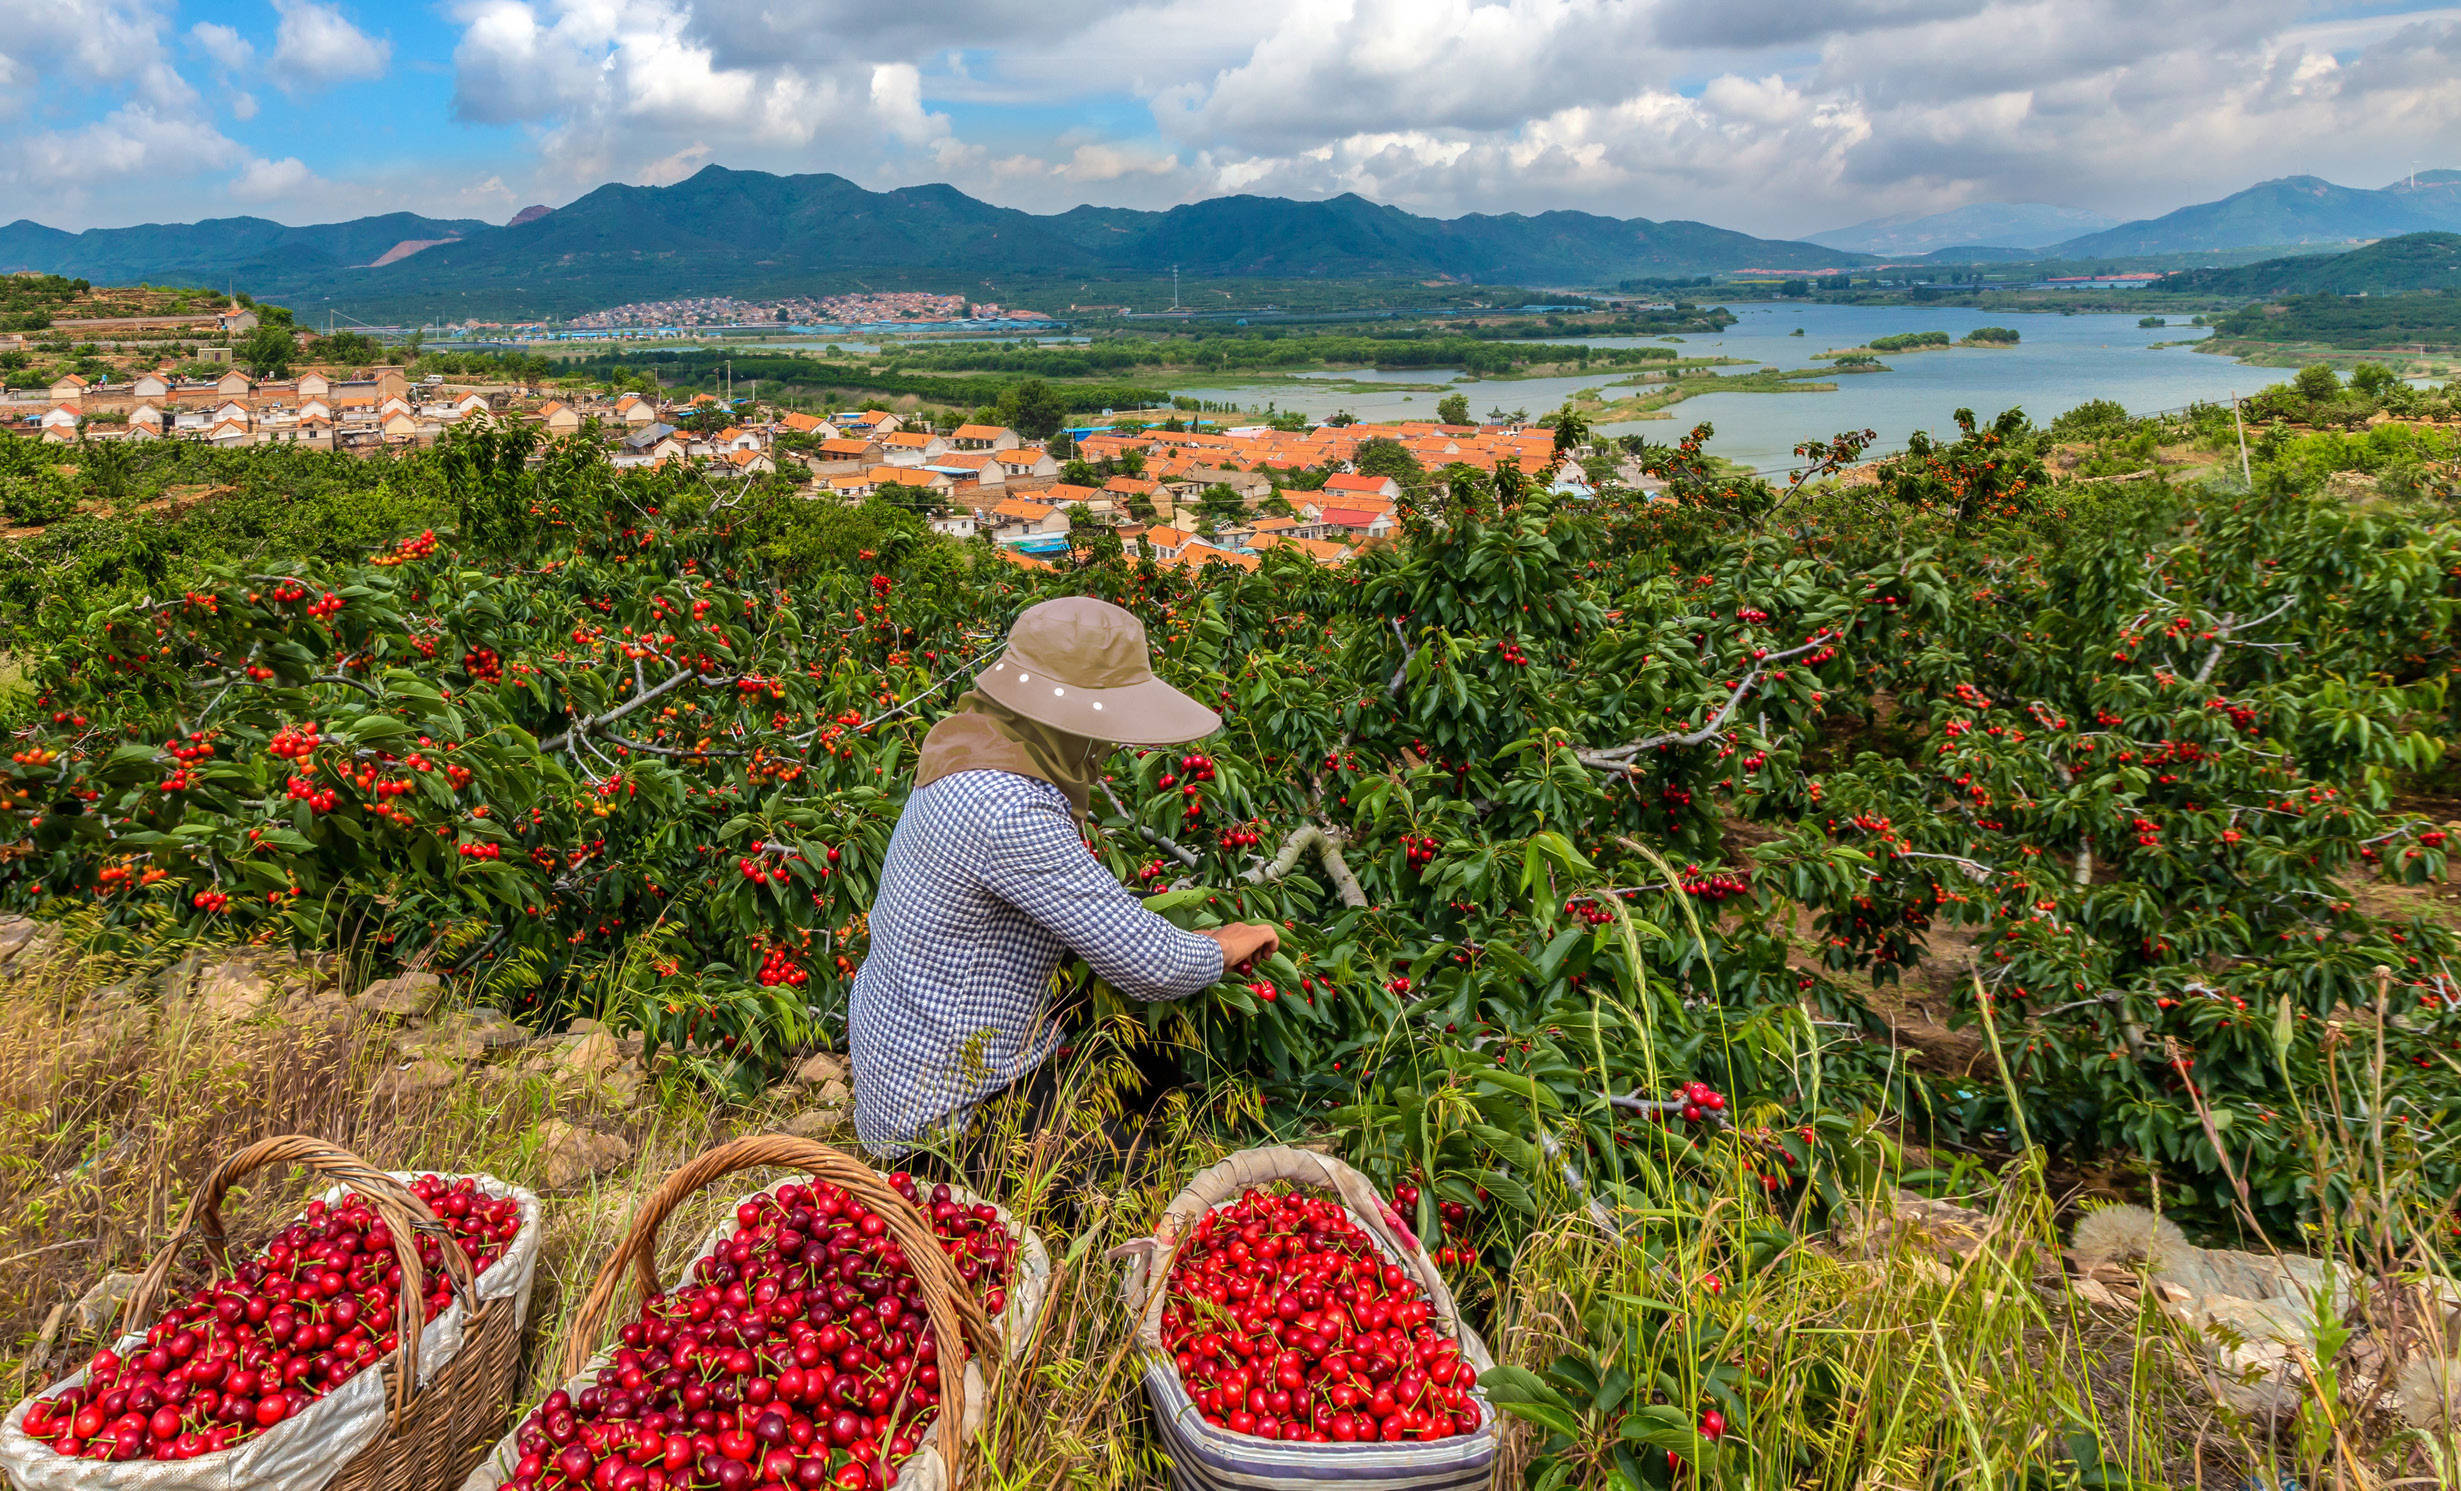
[556,1134,999,1484]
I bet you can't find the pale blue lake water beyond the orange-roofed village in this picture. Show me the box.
[1171,303,2294,470]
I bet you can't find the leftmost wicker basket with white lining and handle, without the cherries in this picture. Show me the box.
[0,1134,539,1491]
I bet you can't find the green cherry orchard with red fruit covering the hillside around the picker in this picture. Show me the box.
[0,401,2461,1486]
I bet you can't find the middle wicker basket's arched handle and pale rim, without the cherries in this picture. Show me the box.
[460,1134,1013,1491]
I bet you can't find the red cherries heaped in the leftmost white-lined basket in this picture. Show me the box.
[25,1180,522,1459]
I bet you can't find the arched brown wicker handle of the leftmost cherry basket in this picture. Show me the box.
[121,1134,477,1429]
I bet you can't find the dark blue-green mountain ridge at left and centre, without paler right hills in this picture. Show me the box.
[0,165,1863,315]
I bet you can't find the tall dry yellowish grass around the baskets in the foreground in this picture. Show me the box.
[0,934,2431,1491]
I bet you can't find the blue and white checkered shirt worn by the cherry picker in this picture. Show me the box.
[847,770,1223,1156]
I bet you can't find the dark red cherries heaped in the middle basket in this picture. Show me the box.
[507,1174,1014,1491]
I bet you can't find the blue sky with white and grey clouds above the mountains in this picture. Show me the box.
[0,0,2461,234]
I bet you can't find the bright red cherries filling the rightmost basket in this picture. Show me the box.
[1162,1191,1479,1444]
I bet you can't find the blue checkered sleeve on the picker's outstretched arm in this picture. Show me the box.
[982,802,1223,999]
